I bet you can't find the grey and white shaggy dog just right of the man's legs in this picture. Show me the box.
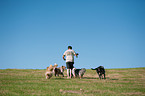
[72,68,86,79]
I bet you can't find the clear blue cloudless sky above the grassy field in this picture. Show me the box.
[0,0,145,69]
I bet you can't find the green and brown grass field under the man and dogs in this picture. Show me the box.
[0,68,145,96]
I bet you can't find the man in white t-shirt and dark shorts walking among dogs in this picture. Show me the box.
[63,46,78,78]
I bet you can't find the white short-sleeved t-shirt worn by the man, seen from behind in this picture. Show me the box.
[63,49,76,62]
